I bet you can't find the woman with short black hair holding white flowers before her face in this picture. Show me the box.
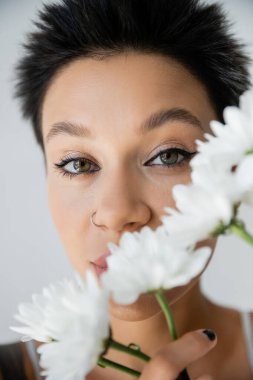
[0,0,253,380]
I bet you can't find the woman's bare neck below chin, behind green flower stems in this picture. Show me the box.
[105,282,210,368]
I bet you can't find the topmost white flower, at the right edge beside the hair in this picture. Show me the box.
[190,89,253,170]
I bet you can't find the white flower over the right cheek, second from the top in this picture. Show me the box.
[162,158,243,244]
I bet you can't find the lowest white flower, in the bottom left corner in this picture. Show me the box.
[12,271,110,380]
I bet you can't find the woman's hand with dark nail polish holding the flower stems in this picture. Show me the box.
[139,330,217,380]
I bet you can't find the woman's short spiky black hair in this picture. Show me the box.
[15,0,250,150]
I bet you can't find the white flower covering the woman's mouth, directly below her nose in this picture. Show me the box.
[101,226,211,304]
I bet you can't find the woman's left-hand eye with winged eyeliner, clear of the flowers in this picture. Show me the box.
[55,157,99,177]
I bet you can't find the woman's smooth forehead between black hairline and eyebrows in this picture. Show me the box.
[42,53,215,138]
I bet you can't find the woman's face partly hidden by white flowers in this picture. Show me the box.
[42,53,217,314]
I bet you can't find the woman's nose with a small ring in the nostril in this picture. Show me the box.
[94,174,152,232]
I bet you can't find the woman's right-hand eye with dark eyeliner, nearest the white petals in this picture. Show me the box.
[146,148,196,167]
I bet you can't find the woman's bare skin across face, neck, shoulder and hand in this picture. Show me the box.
[42,52,250,380]
